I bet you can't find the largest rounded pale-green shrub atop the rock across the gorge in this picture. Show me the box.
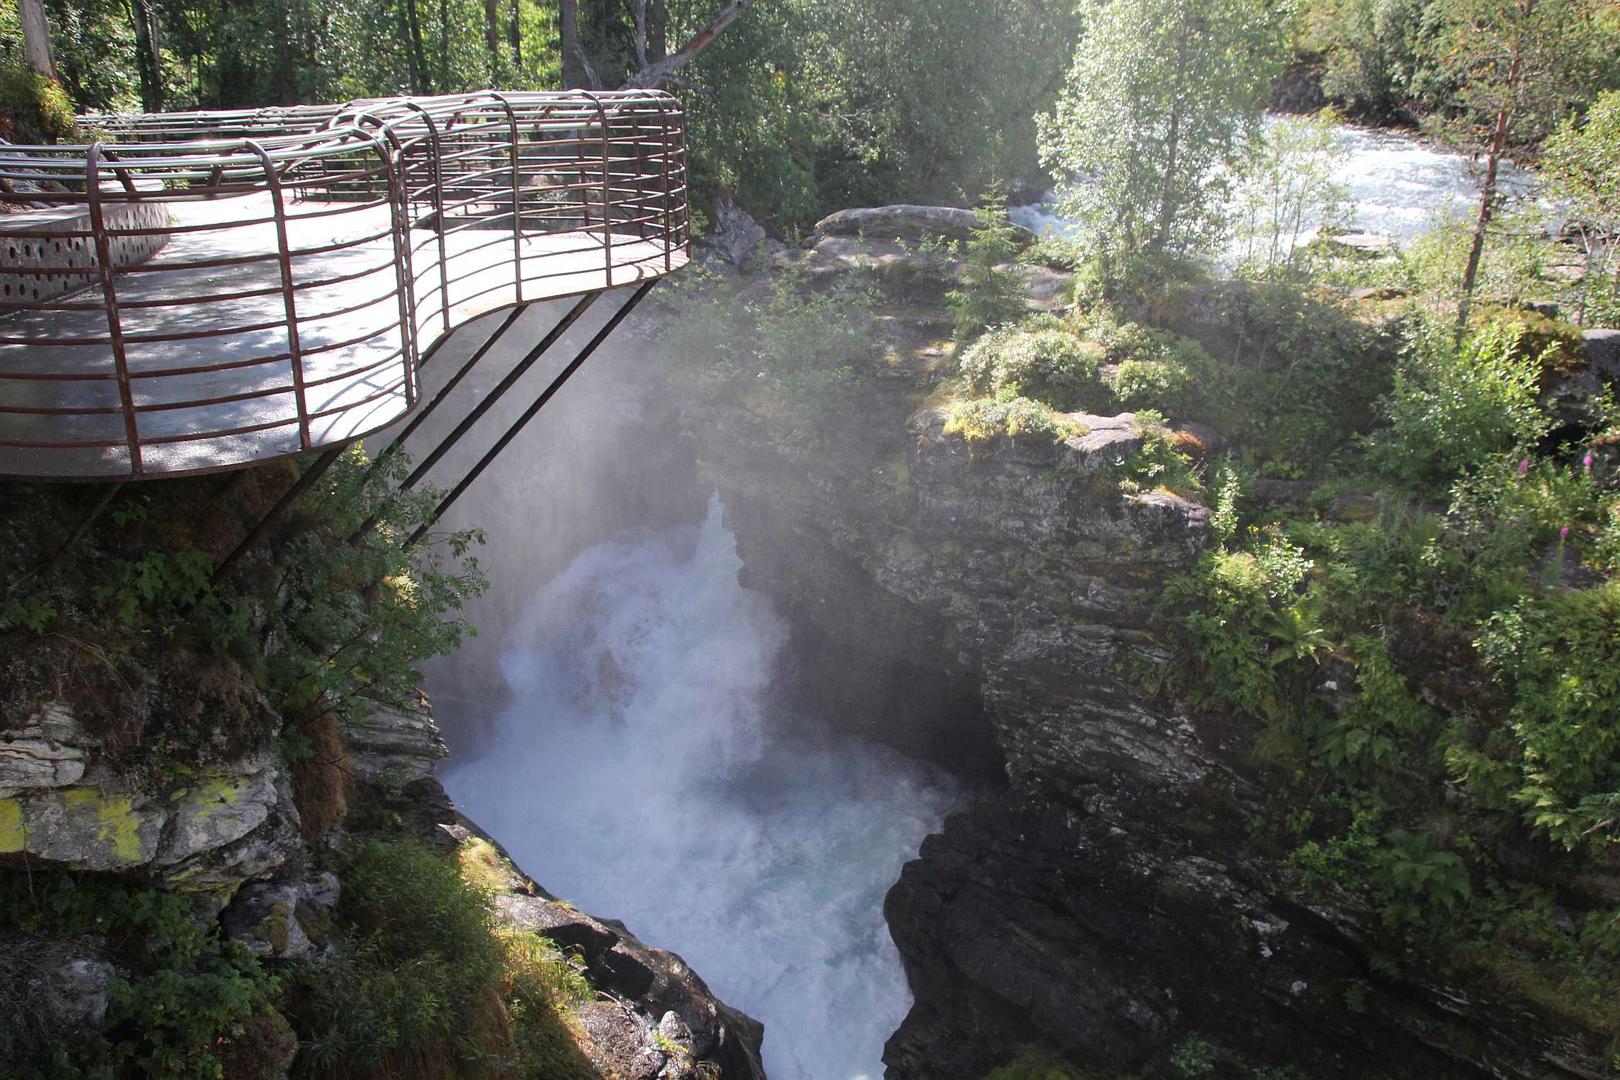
[961,316,1108,413]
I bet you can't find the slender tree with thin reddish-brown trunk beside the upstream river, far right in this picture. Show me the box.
[1432,0,1601,332]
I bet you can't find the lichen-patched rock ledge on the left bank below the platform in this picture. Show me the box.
[0,612,765,1080]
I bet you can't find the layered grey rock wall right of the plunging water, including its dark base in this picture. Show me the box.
[664,210,1605,1080]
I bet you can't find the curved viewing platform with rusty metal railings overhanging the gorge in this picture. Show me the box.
[0,91,690,479]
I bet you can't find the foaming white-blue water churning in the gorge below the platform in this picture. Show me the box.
[444,499,961,1080]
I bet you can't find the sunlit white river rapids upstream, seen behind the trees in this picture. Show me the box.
[1013,117,1534,244]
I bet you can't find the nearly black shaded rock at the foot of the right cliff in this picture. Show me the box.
[885,797,1599,1080]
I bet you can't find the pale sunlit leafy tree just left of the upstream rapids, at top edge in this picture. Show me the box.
[1040,0,1281,254]
